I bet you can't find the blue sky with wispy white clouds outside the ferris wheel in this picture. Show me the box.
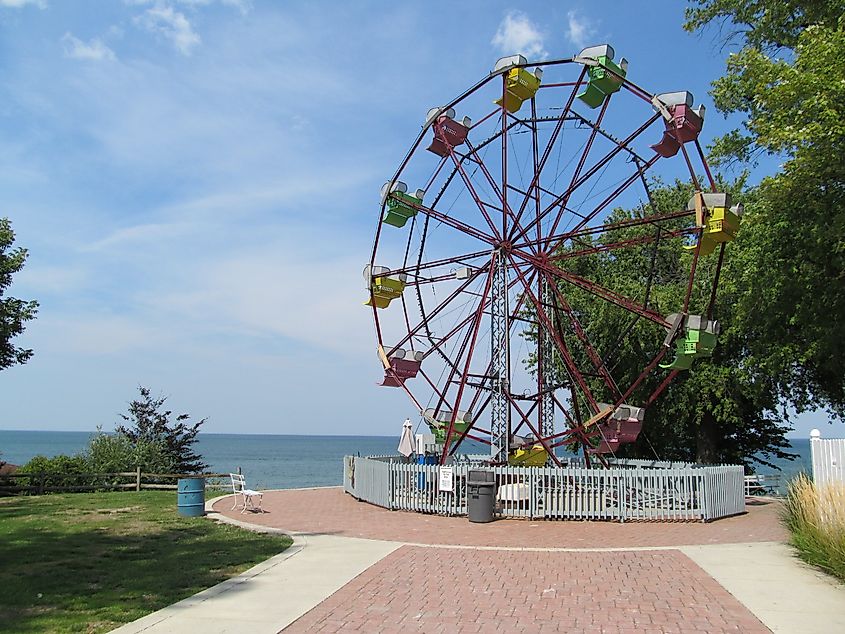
[0,0,832,435]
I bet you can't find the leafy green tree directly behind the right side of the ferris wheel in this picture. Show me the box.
[532,182,790,464]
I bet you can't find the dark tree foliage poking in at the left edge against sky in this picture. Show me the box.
[0,218,38,370]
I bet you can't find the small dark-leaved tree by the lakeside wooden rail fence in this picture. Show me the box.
[115,387,208,473]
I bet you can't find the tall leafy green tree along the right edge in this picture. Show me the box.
[685,0,845,418]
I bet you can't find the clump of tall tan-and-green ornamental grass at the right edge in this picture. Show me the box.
[783,474,845,581]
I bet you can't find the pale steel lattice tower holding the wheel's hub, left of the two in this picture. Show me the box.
[490,249,511,463]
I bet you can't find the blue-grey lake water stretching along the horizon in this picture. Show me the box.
[0,430,811,489]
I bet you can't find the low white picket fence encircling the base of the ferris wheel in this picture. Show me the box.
[343,456,745,522]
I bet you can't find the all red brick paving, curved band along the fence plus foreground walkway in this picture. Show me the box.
[209,488,786,633]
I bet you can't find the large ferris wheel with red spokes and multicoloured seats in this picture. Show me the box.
[364,45,741,465]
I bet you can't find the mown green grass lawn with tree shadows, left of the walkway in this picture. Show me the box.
[0,491,291,633]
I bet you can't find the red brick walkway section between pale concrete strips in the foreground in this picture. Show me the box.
[285,546,769,634]
